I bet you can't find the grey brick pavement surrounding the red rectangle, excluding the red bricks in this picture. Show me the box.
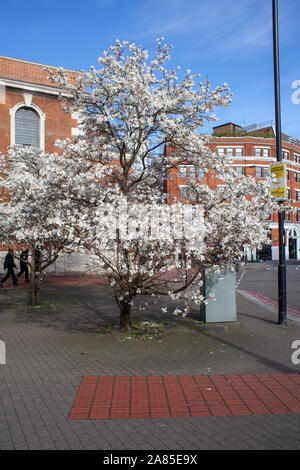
[0,274,300,450]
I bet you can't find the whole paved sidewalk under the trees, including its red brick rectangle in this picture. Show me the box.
[0,276,300,450]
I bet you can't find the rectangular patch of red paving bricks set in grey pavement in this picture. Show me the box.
[69,374,300,419]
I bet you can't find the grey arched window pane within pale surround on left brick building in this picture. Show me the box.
[15,106,40,147]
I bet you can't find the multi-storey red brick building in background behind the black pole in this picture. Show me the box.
[166,123,300,260]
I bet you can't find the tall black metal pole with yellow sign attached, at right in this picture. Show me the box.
[272,0,286,325]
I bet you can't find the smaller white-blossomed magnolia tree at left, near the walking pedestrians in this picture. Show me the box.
[0,146,76,305]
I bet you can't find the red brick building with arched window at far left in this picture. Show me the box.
[0,56,77,153]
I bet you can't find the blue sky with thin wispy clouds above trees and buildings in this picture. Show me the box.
[0,0,300,139]
